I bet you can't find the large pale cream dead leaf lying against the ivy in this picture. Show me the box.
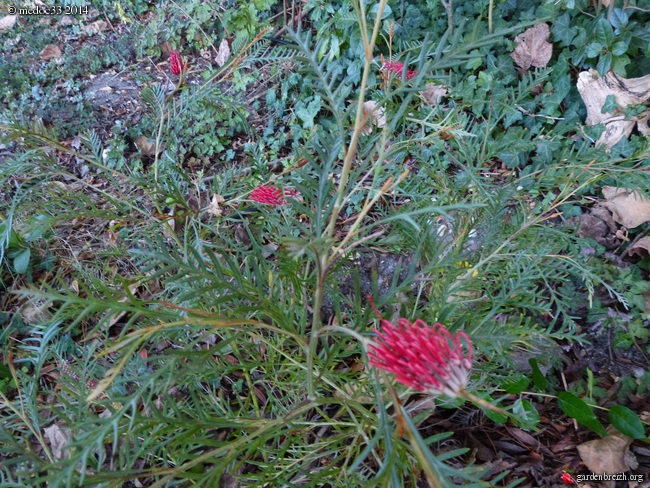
[577,69,650,149]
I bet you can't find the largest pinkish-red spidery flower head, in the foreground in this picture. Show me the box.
[368,298,472,398]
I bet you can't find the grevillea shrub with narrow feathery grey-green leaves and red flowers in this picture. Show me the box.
[0,0,636,488]
